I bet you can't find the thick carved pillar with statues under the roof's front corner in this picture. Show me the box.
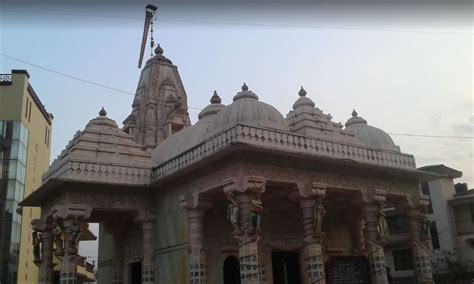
[223,176,267,284]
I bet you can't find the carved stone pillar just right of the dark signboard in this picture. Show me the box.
[362,190,388,284]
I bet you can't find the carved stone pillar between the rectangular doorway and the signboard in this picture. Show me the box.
[289,182,326,284]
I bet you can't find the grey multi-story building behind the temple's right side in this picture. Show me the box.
[384,165,474,283]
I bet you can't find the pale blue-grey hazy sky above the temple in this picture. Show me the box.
[0,0,474,264]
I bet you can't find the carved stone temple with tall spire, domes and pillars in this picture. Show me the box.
[22,46,436,284]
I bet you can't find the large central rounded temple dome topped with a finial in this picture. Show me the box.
[211,83,289,131]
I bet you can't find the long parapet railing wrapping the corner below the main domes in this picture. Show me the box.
[153,124,416,180]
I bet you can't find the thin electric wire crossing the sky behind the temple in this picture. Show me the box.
[0,53,474,139]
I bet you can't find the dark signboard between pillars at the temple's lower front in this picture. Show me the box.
[327,256,370,284]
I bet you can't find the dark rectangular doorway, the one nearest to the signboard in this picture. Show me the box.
[272,251,301,284]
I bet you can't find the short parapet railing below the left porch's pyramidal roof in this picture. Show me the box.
[43,159,152,185]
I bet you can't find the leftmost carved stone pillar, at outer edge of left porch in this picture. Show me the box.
[31,219,53,284]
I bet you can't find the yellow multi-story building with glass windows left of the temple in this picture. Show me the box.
[0,70,53,284]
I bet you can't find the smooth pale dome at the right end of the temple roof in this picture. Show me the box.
[343,110,400,152]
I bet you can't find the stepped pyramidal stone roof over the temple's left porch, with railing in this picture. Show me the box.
[43,108,152,183]
